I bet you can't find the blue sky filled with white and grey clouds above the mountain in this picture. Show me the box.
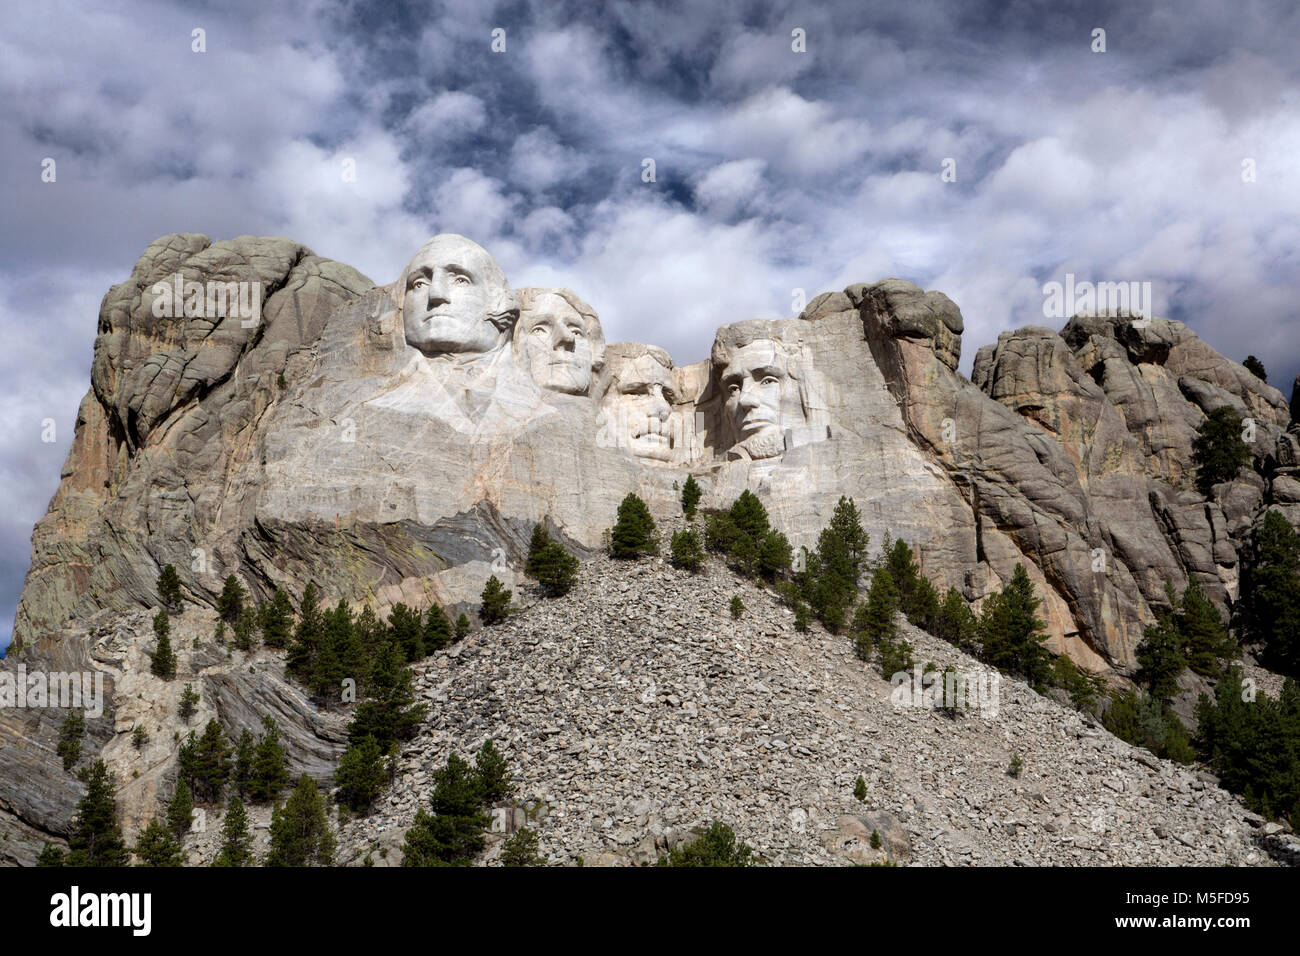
[0,0,1300,644]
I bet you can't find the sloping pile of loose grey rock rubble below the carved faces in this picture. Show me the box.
[339,530,1295,866]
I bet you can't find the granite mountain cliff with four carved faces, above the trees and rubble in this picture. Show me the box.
[14,234,1300,674]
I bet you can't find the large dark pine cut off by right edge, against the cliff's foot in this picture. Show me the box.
[1240,509,1300,676]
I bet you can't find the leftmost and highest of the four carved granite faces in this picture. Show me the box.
[402,235,506,355]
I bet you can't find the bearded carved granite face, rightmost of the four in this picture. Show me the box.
[722,339,806,458]
